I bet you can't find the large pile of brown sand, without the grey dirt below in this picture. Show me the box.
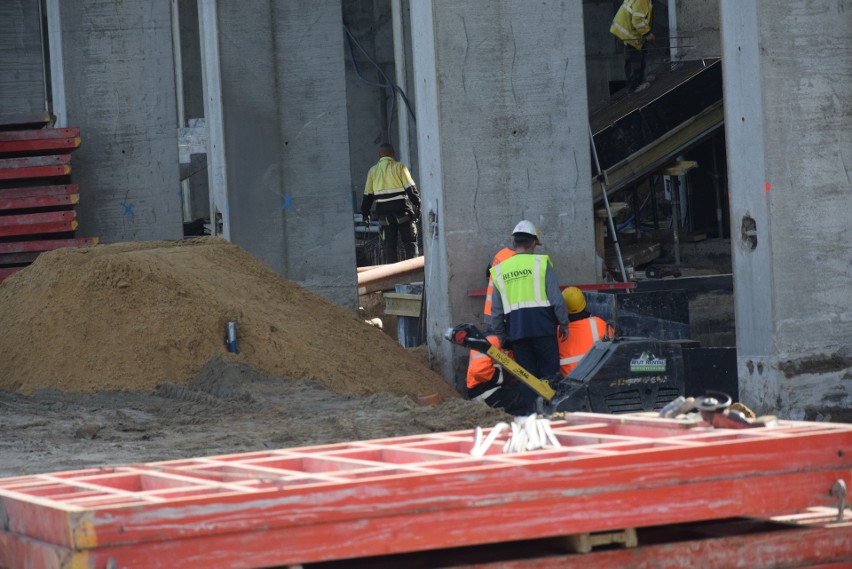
[0,237,457,399]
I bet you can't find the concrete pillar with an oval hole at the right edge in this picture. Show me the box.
[721,0,852,421]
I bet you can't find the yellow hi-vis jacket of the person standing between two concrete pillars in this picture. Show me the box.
[361,156,420,217]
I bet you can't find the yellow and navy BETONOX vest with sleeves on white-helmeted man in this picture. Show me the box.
[491,253,568,340]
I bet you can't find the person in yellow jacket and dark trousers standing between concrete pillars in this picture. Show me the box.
[361,143,420,263]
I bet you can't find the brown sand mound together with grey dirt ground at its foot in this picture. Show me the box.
[0,238,507,477]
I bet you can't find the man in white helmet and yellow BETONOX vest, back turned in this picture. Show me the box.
[490,220,568,405]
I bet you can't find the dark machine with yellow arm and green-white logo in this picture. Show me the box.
[444,324,685,414]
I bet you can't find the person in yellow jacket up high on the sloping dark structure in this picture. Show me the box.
[609,0,657,93]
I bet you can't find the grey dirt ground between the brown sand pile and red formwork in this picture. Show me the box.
[0,356,510,477]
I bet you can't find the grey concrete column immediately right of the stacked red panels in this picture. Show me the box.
[56,0,183,243]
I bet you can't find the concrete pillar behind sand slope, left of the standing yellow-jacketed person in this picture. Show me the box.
[210,0,357,311]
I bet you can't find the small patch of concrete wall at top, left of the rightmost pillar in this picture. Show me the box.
[669,0,722,61]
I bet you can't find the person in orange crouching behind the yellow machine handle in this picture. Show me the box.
[467,334,531,415]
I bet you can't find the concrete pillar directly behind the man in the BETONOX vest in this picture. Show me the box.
[411,0,595,382]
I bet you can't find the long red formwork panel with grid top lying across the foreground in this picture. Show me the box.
[0,413,852,569]
